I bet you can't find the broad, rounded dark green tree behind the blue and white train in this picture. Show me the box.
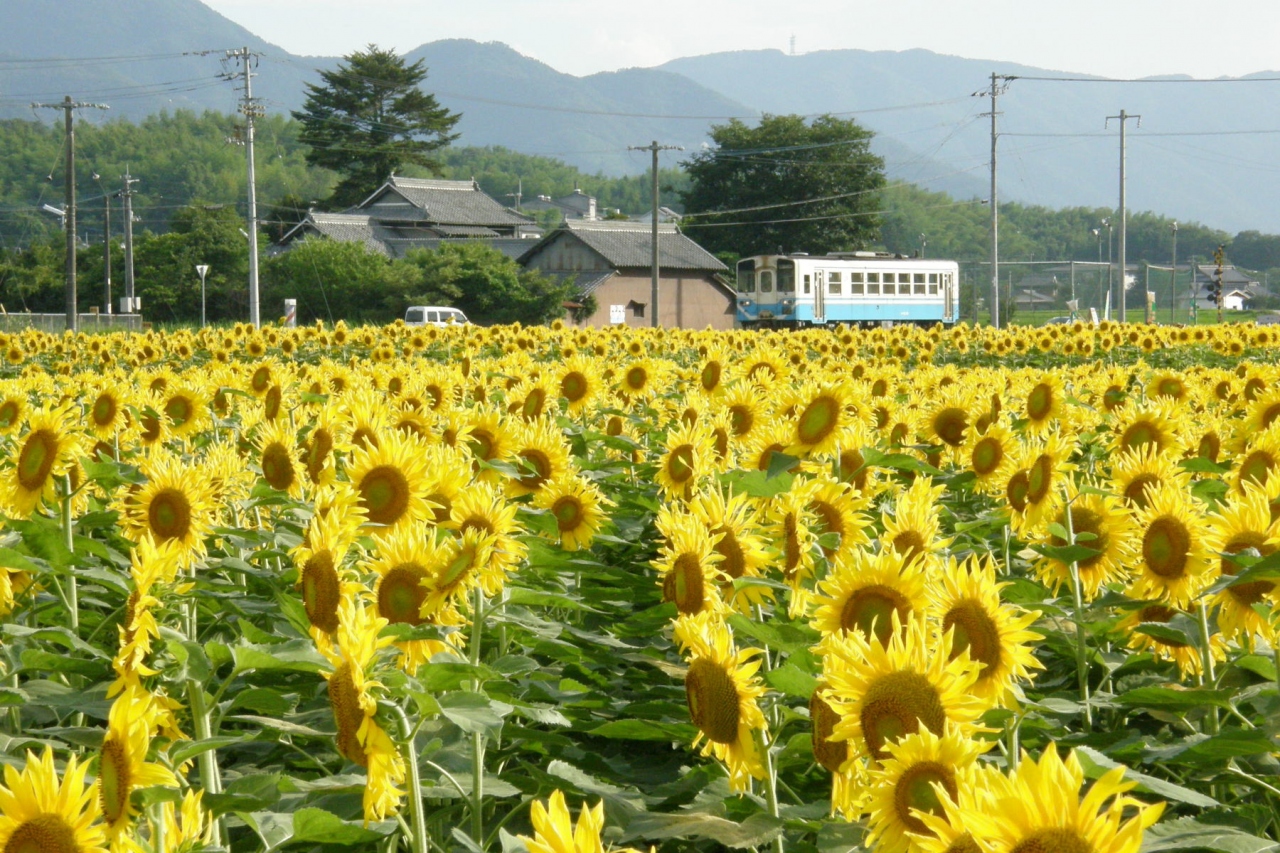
[681,115,884,255]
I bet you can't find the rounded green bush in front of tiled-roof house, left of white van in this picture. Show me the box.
[262,238,430,323]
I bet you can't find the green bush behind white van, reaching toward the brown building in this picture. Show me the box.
[406,242,573,324]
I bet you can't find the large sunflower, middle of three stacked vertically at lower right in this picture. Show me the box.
[823,612,991,761]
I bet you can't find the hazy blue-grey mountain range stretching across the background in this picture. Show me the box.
[0,0,1280,232]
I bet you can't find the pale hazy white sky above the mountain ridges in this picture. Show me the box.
[204,0,1280,77]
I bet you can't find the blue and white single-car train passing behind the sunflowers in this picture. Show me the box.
[737,252,960,328]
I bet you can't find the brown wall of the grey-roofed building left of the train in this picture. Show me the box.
[581,272,735,329]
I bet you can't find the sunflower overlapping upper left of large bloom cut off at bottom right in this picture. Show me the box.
[864,725,992,853]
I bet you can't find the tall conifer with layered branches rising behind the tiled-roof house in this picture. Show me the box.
[293,45,462,207]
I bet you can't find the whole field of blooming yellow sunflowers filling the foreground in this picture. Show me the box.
[0,317,1280,853]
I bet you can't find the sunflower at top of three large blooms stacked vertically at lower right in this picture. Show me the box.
[812,548,928,644]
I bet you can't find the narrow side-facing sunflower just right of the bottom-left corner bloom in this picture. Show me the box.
[96,686,178,849]
